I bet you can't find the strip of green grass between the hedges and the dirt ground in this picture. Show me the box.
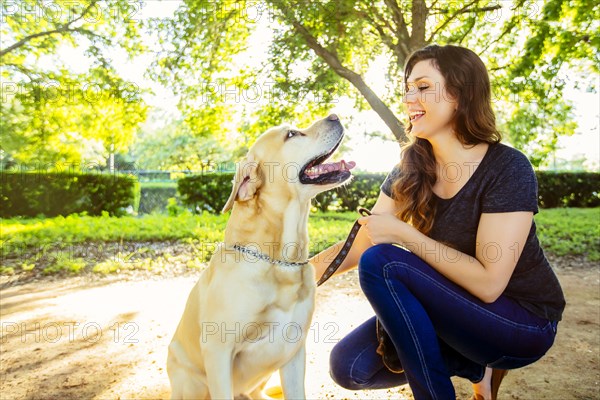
[0,208,600,274]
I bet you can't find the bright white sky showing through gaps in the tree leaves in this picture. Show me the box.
[44,1,600,172]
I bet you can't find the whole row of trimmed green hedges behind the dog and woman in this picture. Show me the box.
[0,171,600,218]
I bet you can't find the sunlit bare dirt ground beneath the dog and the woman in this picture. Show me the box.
[0,259,600,400]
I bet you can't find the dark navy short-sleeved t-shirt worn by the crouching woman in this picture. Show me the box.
[381,143,565,321]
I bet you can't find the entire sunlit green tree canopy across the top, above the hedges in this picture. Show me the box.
[0,0,600,169]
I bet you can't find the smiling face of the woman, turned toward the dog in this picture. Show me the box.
[402,60,458,139]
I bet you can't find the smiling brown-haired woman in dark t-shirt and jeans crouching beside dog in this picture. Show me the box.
[312,45,565,400]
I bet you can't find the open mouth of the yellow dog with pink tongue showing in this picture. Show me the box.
[300,141,356,185]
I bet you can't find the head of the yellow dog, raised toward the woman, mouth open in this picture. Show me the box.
[223,114,355,212]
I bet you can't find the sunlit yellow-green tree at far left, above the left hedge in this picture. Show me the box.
[0,0,146,166]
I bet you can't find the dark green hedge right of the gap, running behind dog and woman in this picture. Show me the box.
[178,171,600,212]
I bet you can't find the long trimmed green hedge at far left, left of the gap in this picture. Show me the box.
[0,171,139,218]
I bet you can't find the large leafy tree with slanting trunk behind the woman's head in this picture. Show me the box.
[156,0,599,165]
